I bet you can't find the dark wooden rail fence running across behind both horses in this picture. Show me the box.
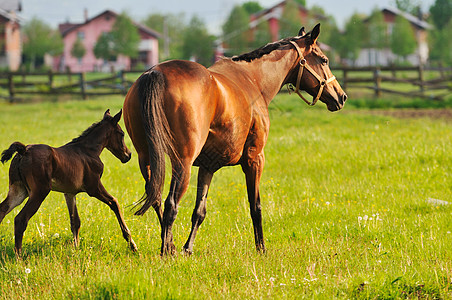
[0,66,452,102]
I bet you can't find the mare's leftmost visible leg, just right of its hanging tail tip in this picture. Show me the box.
[160,163,191,255]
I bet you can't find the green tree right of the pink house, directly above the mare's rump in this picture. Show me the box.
[182,16,214,67]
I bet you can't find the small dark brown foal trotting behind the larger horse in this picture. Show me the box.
[0,110,137,254]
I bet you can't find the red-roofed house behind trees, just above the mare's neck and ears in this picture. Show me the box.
[250,0,326,42]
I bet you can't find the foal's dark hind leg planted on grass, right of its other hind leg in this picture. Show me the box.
[14,189,50,254]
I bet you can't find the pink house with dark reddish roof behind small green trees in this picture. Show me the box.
[53,10,160,72]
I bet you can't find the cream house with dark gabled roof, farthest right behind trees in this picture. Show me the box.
[355,7,433,66]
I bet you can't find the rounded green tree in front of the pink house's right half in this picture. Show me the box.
[111,12,141,58]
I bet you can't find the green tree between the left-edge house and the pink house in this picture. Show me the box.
[23,18,64,70]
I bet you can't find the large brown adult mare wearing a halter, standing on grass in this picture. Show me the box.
[124,24,347,254]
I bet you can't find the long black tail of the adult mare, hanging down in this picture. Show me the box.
[135,69,178,215]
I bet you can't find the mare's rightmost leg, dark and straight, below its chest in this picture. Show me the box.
[242,152,265,252]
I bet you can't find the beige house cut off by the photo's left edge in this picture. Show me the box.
[0,0,22,71]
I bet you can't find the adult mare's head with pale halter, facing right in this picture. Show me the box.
[287,24,347,111]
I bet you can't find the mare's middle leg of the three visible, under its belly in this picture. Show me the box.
[184,167,213,254]
